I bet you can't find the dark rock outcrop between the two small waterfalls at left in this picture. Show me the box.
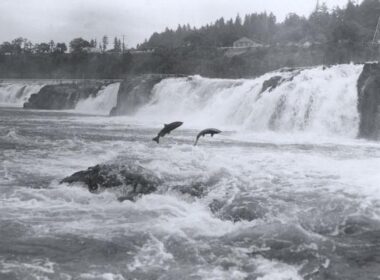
[24,81,107,110]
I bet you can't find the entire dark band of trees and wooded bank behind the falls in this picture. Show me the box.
[0,0,380,78]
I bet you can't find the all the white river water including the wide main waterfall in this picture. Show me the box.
[0,65,380,280]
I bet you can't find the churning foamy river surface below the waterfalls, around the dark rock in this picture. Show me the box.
[0,105,380,280]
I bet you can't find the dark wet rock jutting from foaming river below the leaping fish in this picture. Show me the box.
[61,164,160,201]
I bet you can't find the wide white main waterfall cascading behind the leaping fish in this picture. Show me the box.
[136,65,362,137]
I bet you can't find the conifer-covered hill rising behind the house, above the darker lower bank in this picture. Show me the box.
[139,0,380,49]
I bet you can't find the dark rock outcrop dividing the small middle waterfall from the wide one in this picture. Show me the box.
[110,74,183,116]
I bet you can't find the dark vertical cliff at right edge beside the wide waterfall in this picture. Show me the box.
[357,63,380,140]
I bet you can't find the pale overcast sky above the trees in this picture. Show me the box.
[0,0,354,47]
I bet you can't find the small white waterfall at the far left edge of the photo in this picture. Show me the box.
[0,81,45,107]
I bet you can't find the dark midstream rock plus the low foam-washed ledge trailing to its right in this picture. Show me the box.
[60,161,218,201]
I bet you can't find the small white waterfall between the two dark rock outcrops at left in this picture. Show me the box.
[75,83,120,115]
